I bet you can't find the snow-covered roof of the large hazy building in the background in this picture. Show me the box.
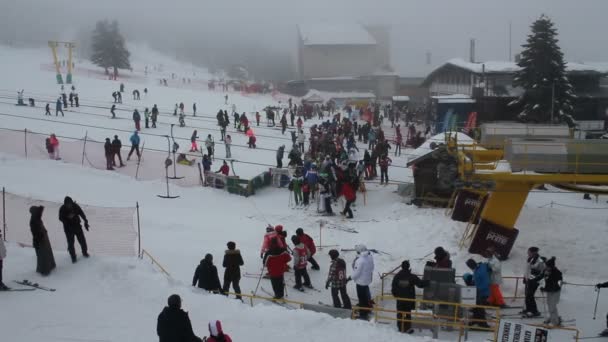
[298,23,376,45]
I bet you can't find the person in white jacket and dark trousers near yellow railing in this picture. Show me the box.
[349,245,374,319]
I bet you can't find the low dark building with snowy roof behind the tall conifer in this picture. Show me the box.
[423,58,608,127]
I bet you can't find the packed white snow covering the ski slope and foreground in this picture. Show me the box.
[0,47,608,342]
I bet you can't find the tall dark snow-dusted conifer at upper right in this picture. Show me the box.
[513,15,575,124]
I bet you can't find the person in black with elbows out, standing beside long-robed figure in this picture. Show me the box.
[59,196,89,263]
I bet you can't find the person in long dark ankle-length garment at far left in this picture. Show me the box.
[28,206,56,276]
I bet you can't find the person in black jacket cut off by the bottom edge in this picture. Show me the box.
[156,294,202,342]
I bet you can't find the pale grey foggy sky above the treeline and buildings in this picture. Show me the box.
[0,0,608,76]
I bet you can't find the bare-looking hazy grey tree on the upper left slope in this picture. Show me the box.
[91,20,131,79]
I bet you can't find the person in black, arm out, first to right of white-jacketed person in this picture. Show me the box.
[391,260,429,334]
